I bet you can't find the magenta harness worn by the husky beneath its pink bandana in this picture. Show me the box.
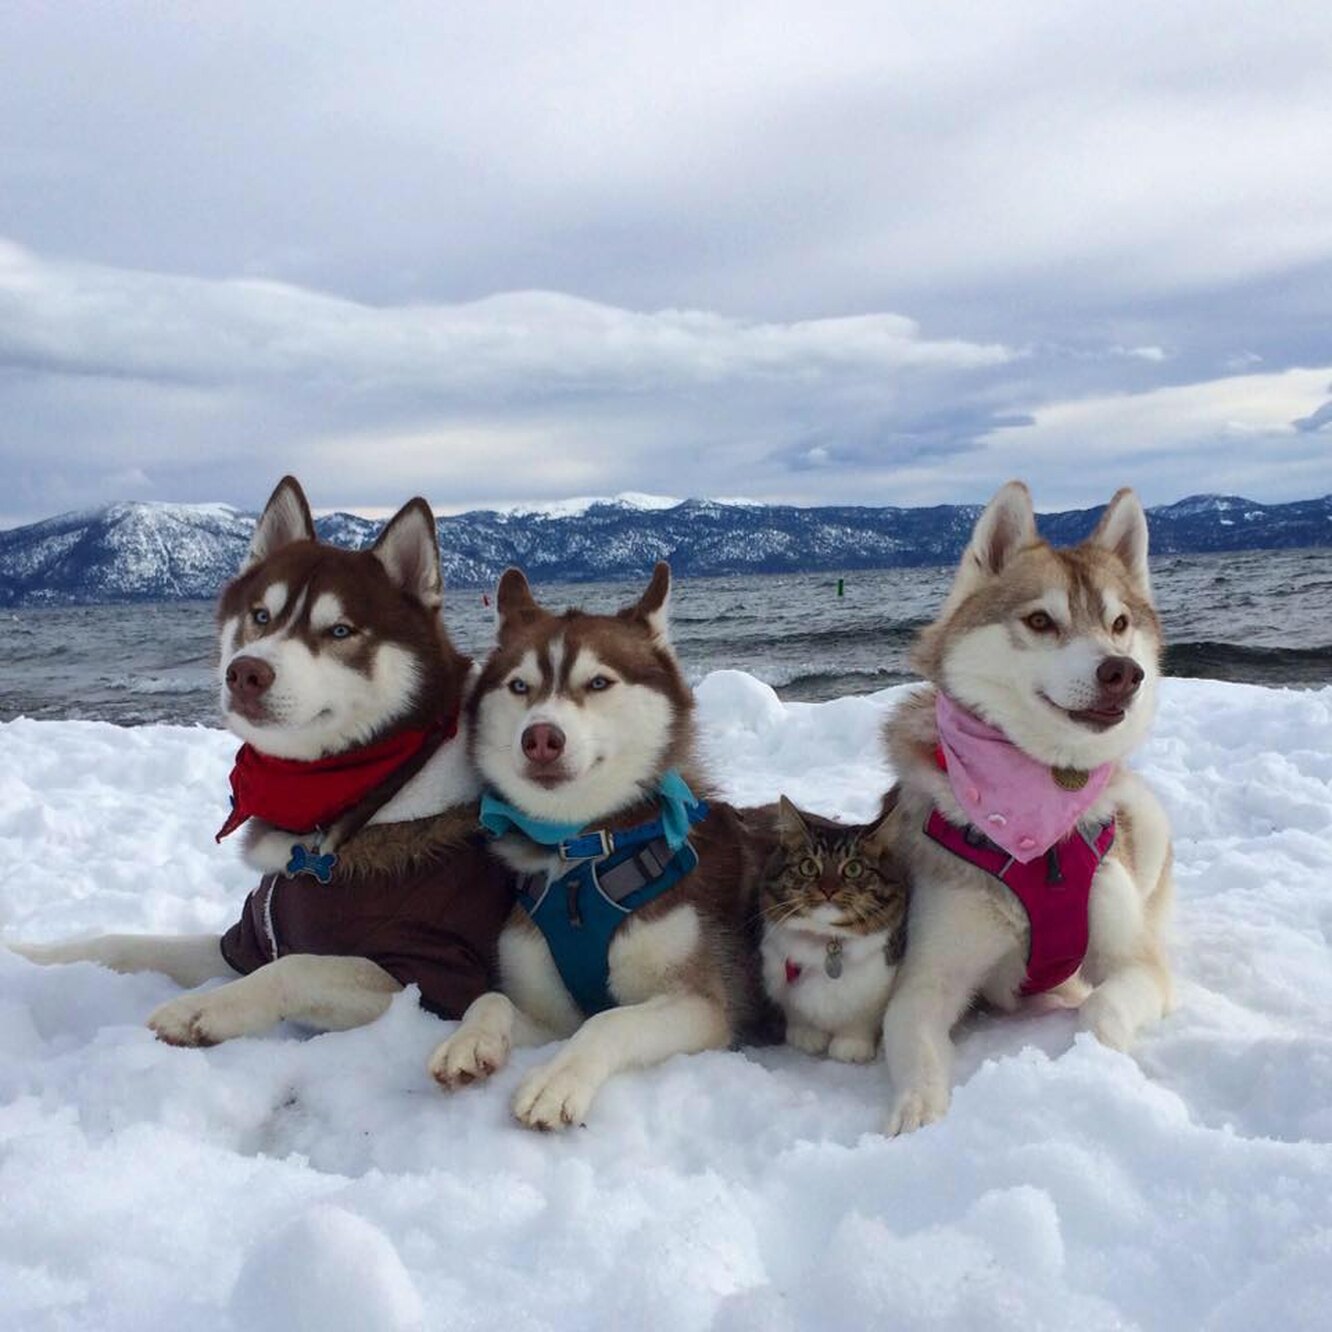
[924,810,1115,995]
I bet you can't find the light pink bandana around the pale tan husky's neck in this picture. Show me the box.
[934,690,1114,864]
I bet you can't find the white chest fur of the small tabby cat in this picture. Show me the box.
[762,924,896,1034]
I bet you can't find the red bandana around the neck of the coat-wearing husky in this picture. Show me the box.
[217,717,458,842]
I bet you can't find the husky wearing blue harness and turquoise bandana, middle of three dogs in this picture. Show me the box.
[429,563,762,1128]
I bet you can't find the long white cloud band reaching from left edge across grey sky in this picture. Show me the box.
[0,245,1012,397]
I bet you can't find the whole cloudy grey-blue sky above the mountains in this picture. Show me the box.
[0,0,1332,526]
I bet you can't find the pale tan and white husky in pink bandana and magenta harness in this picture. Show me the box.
[883,482,1171,1134]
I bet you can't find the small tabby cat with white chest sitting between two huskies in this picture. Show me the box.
[759,795,907,1062]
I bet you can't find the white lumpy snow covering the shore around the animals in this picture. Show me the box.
[0,671,1332,1332]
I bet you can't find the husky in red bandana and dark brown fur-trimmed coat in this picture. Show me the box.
[12,477,513,1046]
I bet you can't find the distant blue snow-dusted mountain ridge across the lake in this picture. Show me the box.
[0,496,1332,606]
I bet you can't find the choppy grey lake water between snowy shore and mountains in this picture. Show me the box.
[0,550,1332,725]
